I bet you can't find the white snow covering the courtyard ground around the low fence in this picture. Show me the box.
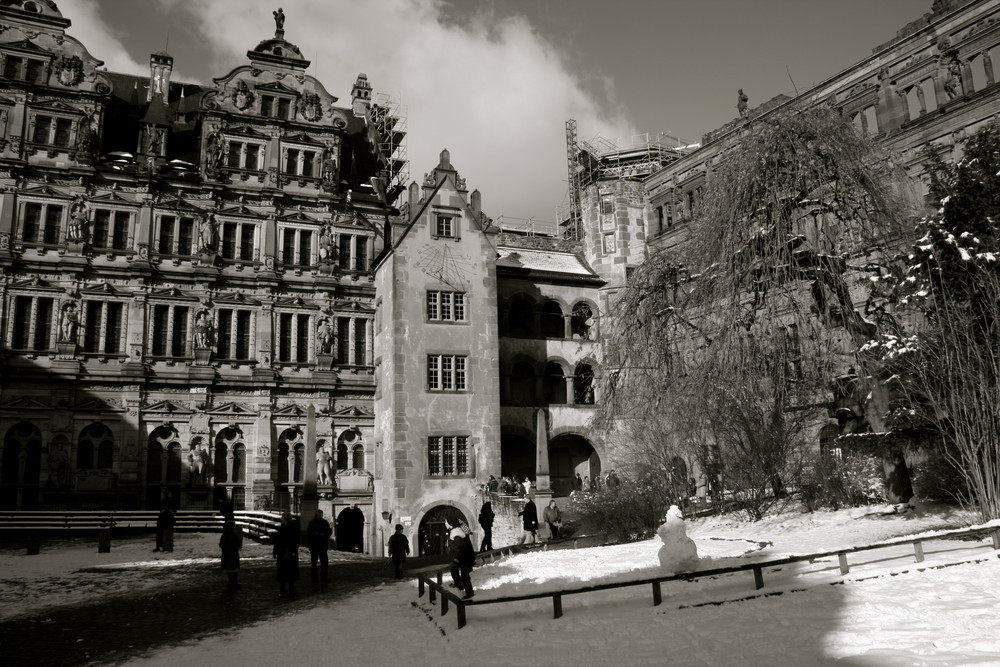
[0,506,1000,667]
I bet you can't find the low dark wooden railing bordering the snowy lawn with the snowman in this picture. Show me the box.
[417,525,1000,629]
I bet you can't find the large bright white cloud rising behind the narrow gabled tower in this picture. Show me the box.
[160,0,635,221]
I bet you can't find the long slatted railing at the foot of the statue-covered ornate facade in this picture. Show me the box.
[0,510,281,542]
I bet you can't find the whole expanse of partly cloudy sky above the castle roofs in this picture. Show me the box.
[59,0,931,222]
